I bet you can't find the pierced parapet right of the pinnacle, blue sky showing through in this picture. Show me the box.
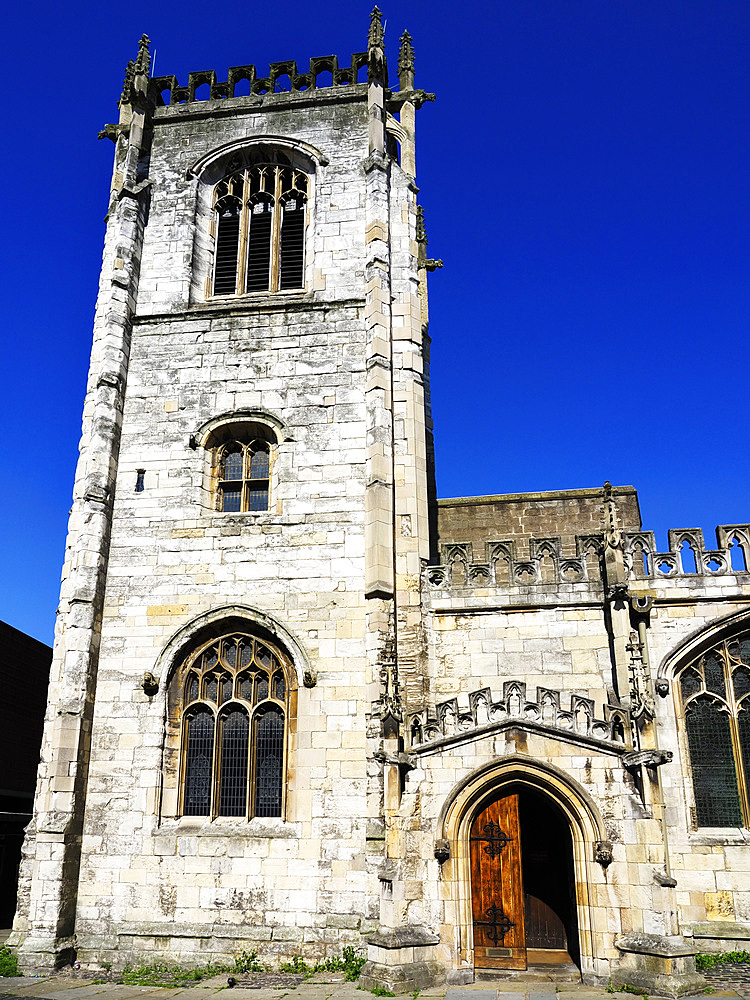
[623,524,750,579]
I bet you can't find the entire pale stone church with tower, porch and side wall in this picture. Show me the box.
[13,9,750,995]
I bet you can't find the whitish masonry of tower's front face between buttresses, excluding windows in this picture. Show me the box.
[70,88,388,962]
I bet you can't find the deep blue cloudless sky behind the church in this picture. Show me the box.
[0,0,750,642]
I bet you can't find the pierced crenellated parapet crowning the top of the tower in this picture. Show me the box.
[149,52,367,106]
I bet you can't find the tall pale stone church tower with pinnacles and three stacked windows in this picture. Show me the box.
[14,8,435,967]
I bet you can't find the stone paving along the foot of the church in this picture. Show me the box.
[0,964,750,1000]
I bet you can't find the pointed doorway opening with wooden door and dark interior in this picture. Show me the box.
[469,784,580,969]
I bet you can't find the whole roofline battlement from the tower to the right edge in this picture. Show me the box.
[425,524,750,592]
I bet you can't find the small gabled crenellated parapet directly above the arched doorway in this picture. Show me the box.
[407,680,630,749]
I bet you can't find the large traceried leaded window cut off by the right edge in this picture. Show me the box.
[679,632,750,827]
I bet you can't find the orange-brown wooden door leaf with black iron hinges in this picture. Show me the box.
[469,794,526,969]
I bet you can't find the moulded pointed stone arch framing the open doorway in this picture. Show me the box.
[436,754,608,973]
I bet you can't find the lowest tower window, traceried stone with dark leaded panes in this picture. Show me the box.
[181,633,288,819]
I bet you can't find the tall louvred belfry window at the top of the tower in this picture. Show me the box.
[212,164,309,295]
